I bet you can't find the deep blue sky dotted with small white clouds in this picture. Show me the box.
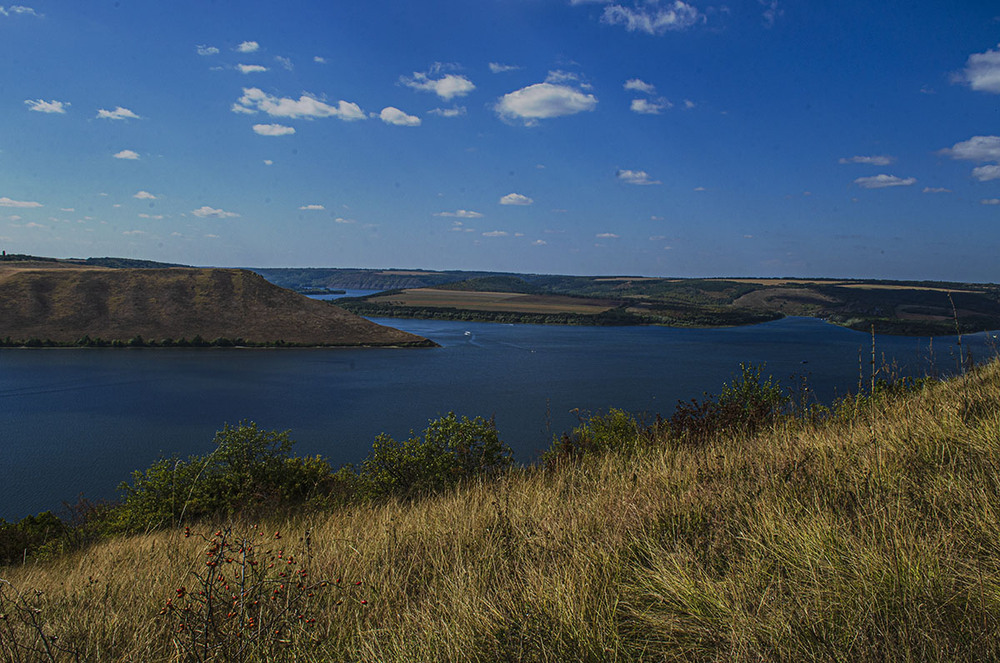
[0,0,1000,282]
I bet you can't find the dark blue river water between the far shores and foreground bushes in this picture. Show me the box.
[0,318,993,520]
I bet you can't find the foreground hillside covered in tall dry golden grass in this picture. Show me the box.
[0,362,1000,663]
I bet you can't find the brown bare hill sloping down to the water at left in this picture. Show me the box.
[0,261,432,346]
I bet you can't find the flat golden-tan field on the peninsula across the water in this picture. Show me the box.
[369,288,618,315]
